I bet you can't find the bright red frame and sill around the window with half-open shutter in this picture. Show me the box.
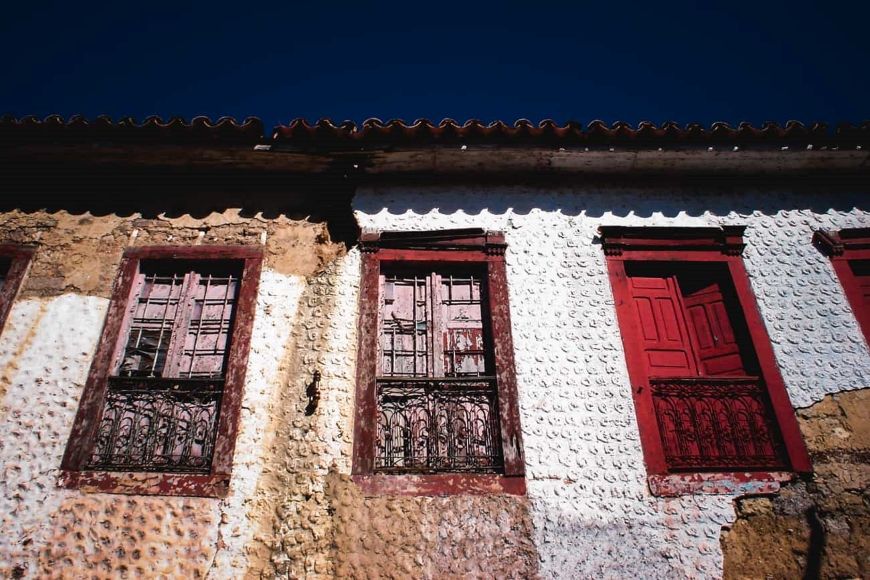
[599,226,812,495]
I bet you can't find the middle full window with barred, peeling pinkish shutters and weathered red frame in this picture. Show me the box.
[354,230,525,494]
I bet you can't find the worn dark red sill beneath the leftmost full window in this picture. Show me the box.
[59,470,230,498]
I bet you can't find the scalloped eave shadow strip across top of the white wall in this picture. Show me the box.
[354,184,868,218]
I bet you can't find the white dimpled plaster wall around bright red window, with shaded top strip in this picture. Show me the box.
[351,187,870,578]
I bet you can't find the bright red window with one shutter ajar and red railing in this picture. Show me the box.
[600,227,809,494]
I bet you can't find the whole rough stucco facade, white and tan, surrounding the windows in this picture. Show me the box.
[0,187,870,578]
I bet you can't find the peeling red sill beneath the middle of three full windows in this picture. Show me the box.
[352,473,526,496]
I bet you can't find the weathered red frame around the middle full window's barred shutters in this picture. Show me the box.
[352,229,526,495]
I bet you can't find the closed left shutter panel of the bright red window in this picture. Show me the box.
[628,276,698,377]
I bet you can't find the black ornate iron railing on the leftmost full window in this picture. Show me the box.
[87,377,223,473]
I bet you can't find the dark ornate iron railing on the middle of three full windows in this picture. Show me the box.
[375,377,503,473]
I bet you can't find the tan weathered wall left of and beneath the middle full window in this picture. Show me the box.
[249,251,537,578]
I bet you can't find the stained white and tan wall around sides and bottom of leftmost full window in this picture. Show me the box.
[0,270,305,578]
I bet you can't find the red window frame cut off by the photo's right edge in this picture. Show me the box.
[813,228,870,345]
